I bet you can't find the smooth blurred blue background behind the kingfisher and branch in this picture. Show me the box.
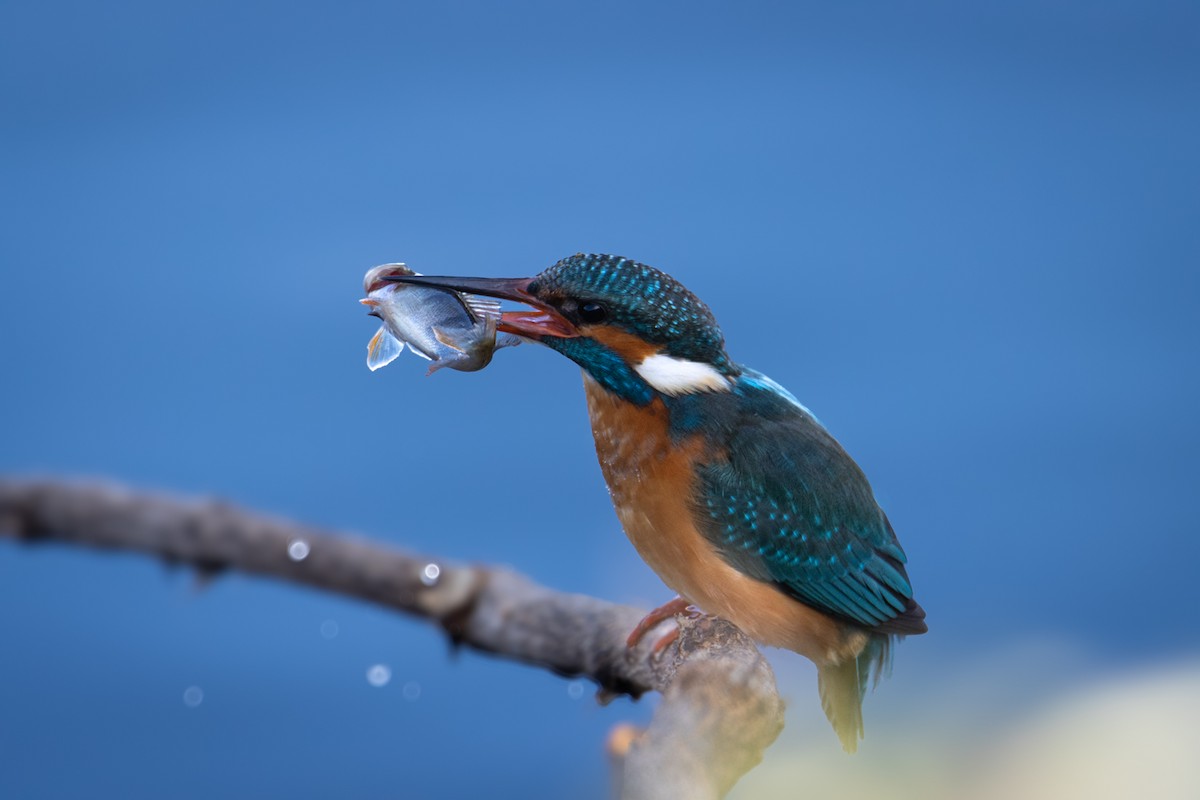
[0,0,1200,799]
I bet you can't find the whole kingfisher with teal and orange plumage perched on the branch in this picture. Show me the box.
[385,253,928,752]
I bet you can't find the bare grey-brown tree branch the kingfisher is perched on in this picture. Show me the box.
[0,477,784,800]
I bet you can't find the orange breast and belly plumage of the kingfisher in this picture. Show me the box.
[583,373,866,664]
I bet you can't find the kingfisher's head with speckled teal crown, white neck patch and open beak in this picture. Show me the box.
[384,253,738,405]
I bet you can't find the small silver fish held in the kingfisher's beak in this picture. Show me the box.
[359,264,521,374]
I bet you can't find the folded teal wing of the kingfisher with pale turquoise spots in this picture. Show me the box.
[698,379,926,633]
